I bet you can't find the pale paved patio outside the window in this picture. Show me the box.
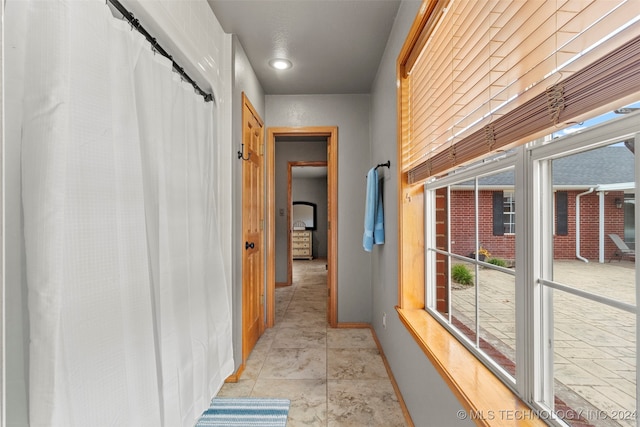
[452,260,636,426]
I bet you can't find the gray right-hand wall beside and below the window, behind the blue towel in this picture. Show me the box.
[371,0,473,426]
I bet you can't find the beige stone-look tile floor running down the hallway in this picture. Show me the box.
[218,260,407,427]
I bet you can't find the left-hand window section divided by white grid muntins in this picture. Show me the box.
[427,165,516,381]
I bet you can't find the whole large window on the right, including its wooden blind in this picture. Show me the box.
[398,0,640,425]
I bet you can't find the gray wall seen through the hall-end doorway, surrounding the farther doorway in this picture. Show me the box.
[269,139,327,283]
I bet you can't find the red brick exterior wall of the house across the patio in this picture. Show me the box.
[451,191,624,261]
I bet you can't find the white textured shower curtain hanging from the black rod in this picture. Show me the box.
[5,0,233,427]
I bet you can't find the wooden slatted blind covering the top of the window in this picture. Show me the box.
[399,0,640,183]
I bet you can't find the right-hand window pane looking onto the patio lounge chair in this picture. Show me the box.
[538,143,637,425]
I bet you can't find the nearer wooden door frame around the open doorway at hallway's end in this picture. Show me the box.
[266,126,338,328]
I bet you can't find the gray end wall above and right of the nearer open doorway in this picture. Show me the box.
[265,94,376,322]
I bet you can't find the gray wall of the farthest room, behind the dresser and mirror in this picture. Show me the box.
[291,177,328,258]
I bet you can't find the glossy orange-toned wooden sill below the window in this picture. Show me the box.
[397,308,546,427]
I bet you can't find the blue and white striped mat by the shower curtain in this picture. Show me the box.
[196,397,291,427]
